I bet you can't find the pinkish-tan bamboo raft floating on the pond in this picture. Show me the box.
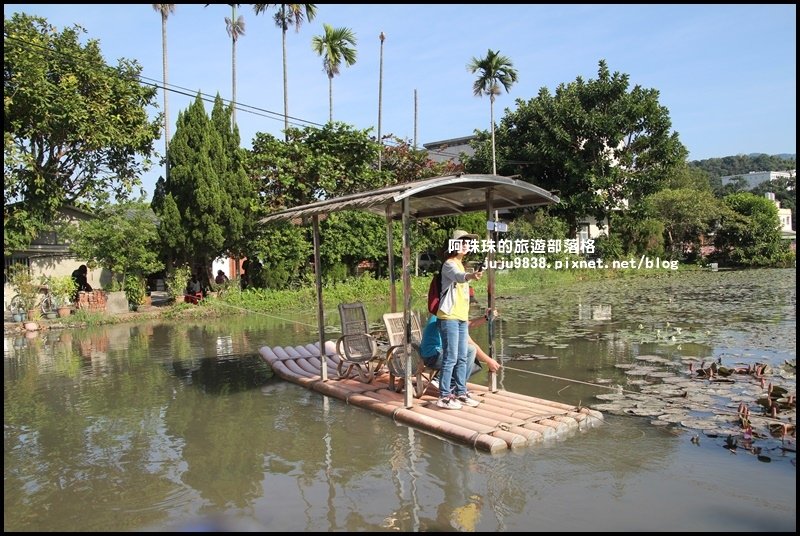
[259,341,603,454]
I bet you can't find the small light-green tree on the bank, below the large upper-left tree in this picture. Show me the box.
[65,200,164,285]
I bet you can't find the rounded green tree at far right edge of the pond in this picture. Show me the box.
[714,192,787,266]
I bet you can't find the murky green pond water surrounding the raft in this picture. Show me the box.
[3,270,796,532]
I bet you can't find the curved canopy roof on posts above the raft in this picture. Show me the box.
[261,174,559,223]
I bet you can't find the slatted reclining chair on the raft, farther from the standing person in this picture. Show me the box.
[336,302,386,383]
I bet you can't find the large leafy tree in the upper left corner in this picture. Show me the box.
[3,13,161,252]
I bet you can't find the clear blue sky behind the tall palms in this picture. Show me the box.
[4,4,797,196]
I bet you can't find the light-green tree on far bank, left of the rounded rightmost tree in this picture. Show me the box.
[647,188,721,258]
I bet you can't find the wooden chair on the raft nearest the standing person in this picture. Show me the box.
[383,311,439,398]
